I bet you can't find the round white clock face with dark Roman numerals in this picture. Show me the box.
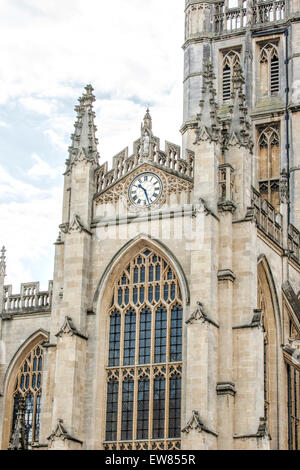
[129,173,163,207]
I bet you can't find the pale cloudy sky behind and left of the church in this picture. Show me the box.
[0,0,184,293]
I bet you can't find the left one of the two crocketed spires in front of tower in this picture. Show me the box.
[196,62,220,143]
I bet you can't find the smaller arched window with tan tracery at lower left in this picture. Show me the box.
[11,344,43,448]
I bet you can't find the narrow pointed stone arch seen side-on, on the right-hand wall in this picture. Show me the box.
[257,255,282,450]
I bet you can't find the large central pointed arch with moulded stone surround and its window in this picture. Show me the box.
[94,234,189,450]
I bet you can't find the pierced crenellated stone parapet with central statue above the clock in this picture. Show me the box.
[96,110,194,195]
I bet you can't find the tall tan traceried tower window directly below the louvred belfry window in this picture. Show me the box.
[258,124,280,210]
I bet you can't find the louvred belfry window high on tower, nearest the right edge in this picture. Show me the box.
[260,43,280,96]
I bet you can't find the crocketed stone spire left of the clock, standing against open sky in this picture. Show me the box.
[67,85,99,165]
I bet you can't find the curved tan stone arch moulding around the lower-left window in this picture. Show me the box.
[2,329,49,449]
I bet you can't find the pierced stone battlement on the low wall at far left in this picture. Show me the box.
[2,281,53,316]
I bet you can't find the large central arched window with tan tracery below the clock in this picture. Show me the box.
[104,249,183,450]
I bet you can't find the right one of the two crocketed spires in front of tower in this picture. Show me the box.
[227,63,253,152]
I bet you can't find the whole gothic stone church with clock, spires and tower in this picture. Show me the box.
[0,0,300,450]
